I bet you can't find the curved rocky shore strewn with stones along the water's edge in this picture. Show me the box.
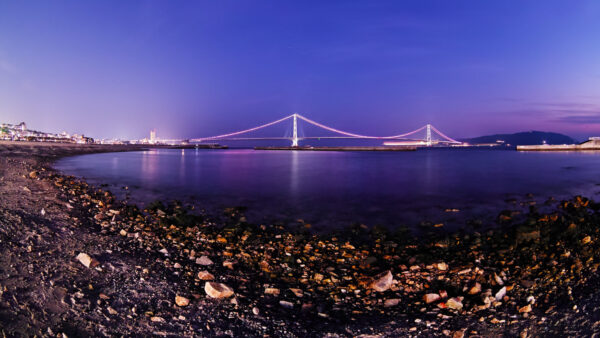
[0,143,600,337]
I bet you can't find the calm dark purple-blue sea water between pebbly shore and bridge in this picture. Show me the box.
[55,149,600,229]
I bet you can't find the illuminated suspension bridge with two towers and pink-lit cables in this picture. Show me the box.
[189,114,462,147]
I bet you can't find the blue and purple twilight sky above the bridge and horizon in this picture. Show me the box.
[0,0,600,138]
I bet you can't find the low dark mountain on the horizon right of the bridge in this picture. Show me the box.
[462,131,579,146]
